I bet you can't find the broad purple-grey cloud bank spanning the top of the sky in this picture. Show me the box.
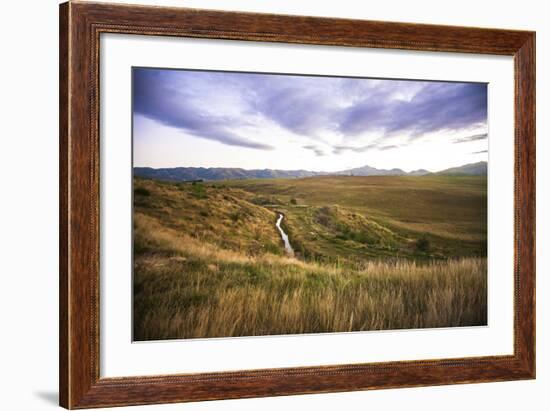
[134,68,487,152]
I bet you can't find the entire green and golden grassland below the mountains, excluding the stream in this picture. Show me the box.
[134,176,487,340]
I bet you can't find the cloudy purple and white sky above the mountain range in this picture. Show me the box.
[133,68,488,171]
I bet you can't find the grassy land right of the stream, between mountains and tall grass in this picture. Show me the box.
[219,176,487,259]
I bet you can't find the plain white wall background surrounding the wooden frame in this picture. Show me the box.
[0,0,550,411]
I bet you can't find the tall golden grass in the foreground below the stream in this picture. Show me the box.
[134,214,487,340]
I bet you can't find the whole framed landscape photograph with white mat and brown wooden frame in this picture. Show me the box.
[60,2,535,409]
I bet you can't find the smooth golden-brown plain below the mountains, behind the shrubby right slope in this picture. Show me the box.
[224,175,487,246]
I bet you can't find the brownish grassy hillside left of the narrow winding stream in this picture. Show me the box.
[134,179,283,255]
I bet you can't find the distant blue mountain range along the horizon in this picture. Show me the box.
[134,161,487,181]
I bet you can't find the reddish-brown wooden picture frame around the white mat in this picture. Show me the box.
[59,2,535,409]
